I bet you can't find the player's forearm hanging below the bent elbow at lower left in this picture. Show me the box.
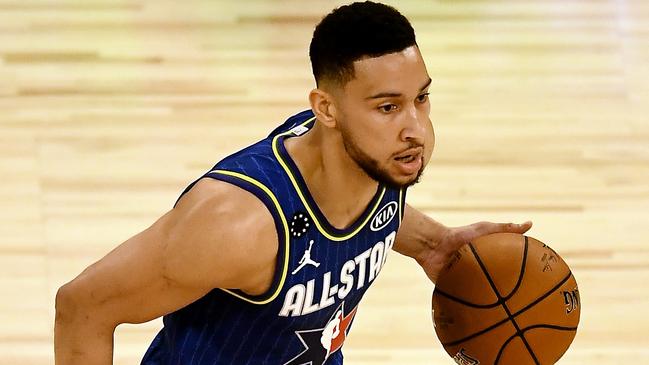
[54,284,115,365]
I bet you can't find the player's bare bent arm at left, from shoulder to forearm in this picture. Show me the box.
[54,179,278,365]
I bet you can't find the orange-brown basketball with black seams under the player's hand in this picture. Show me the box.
[432,233,581,365]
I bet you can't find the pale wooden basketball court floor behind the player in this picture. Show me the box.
[0,0,649,365]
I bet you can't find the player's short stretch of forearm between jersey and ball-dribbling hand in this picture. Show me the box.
[394,205,448,260]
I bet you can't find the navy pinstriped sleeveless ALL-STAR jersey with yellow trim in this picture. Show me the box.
[142,111,405,365]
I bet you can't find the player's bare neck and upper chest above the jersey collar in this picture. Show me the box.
[285,122,378,229]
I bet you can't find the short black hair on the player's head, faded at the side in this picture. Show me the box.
[309,1,417,86]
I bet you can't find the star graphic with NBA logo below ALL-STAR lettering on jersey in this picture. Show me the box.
[284,302,356,365]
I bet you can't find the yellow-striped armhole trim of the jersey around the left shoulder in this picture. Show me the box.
[204,170,289,305]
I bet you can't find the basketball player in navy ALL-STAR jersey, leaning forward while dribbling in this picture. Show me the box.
[55,2,531,365]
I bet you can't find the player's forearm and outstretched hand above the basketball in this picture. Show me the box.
[393,204,532,282]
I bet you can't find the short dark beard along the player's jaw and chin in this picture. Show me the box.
[341,130,424,189]
